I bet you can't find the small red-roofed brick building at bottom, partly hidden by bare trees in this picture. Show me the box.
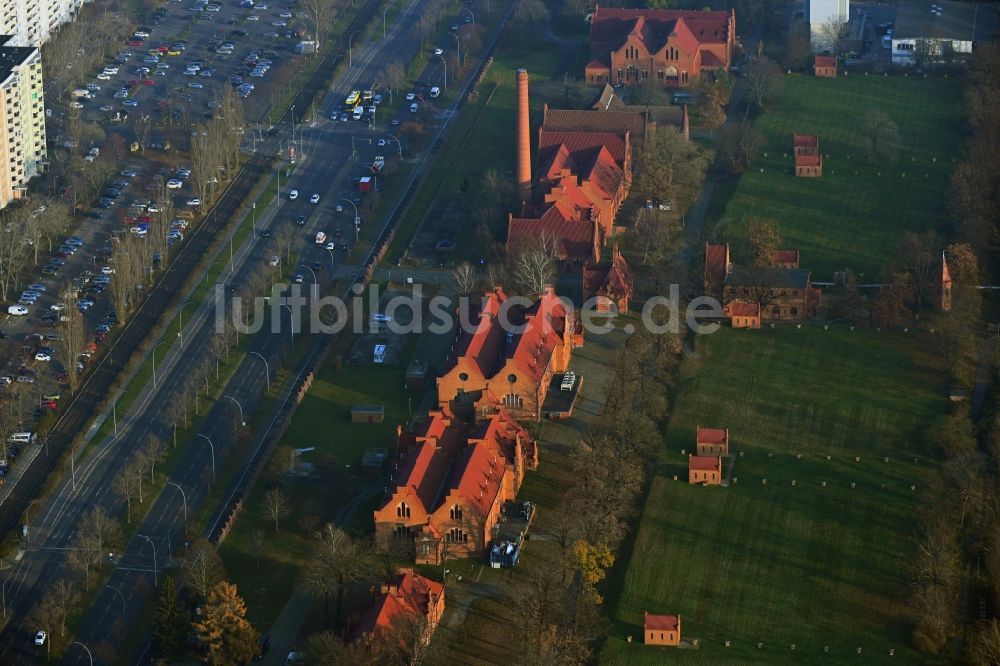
[354,568,444,644]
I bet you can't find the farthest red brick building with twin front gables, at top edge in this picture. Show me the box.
[584,6,736,88]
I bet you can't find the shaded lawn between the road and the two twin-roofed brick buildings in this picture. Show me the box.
[219,363,407,630]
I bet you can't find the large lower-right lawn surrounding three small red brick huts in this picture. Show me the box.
[600,327,946,664]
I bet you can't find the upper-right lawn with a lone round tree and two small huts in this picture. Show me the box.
[713,75,962,280]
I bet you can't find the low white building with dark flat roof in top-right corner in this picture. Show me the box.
[892,0,998,65]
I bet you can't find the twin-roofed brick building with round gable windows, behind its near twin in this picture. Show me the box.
[437,287,576,420]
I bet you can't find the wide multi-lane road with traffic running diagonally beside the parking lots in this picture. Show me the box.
[0,0,476,663]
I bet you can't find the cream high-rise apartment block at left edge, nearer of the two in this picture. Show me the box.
[0,35,46,208]
